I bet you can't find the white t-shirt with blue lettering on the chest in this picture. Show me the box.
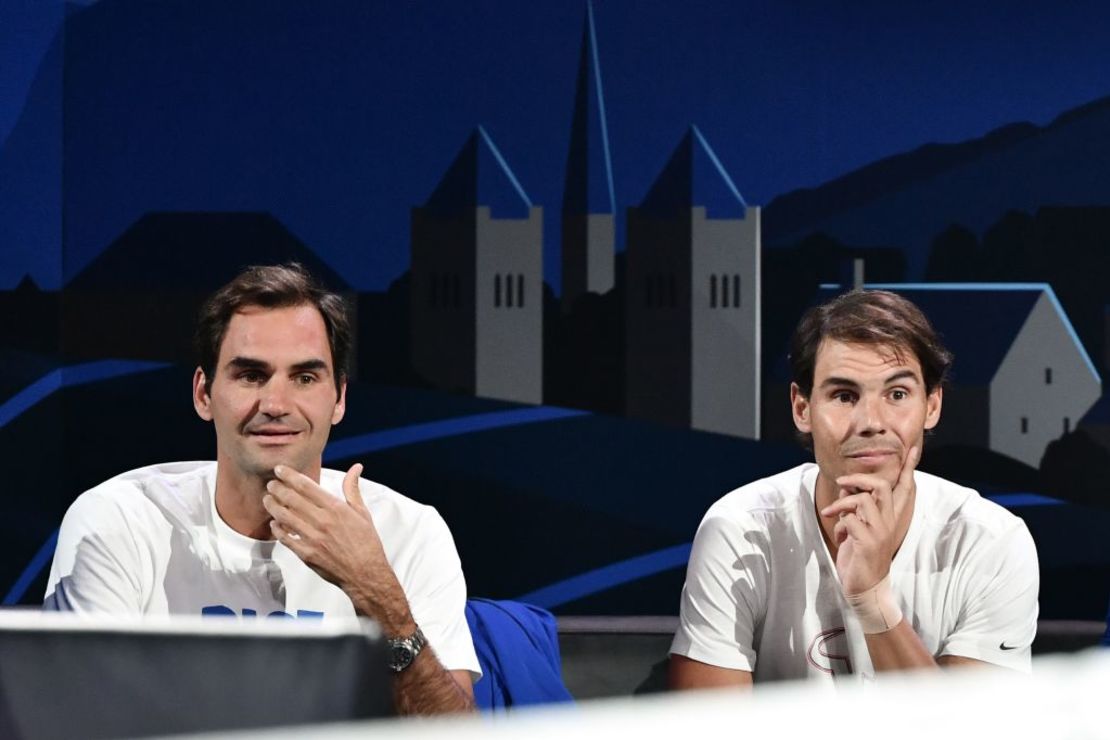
[44,462,481,676]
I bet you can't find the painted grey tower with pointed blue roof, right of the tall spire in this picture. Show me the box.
[625,126,760,439]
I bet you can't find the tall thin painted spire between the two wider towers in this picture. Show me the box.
[562,2,615,313]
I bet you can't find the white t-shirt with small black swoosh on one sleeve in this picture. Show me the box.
[670,463,1040,681]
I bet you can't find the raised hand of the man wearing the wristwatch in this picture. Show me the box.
[262,463,415,635]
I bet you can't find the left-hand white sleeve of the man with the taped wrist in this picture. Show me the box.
[670,509,767,672]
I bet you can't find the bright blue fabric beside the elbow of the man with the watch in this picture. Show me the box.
[466,599,574,710]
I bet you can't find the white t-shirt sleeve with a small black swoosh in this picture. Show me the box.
[938,519,1040,672]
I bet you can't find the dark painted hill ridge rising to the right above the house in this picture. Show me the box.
[764,98,1110,281]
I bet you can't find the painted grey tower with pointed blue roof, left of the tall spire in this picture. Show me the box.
[410,126,543,404]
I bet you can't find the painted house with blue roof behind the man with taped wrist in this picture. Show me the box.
[821,283,1102,467]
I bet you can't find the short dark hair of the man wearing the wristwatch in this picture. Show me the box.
[193,262,351,393]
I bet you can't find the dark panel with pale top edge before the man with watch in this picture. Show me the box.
[0,610,393,740]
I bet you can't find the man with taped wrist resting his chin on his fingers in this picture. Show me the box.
[669,291,1039,689]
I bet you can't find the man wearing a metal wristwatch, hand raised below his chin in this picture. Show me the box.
[46,264,480,713]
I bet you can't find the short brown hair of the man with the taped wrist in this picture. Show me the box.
[789,290,952,398]
